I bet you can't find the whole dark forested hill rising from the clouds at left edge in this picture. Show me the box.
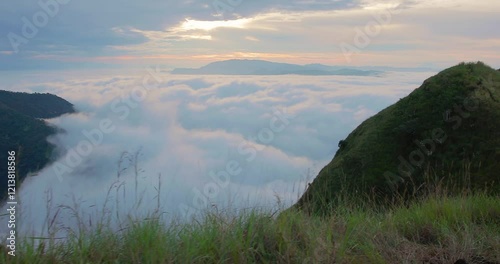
[0,91,75,200]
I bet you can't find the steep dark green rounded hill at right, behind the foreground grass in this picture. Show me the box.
[295,62,500,214]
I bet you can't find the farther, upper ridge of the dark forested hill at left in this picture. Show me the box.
[0,90,75,118]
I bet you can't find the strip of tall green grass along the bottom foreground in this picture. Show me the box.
[0,179,500,264]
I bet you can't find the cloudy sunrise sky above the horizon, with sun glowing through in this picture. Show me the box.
[0,0,500,70]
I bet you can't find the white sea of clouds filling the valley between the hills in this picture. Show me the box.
[0,67,433,238]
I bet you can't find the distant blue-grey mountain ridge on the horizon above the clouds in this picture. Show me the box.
[171,60,383,76]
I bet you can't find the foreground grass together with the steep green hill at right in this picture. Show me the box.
[0,66,500,264]
